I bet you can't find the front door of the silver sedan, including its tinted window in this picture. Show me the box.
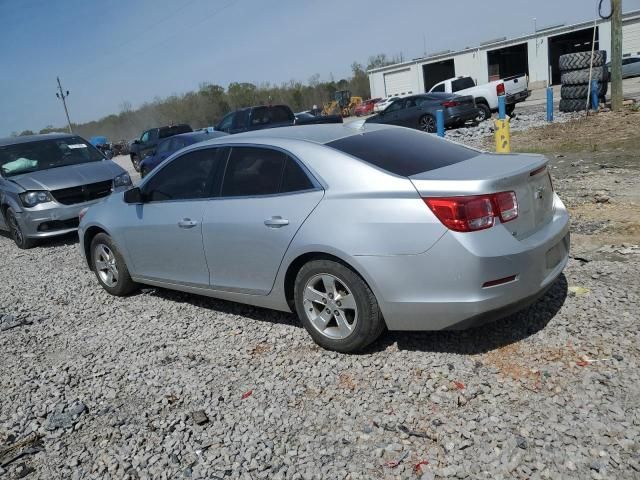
[121,148,218,287]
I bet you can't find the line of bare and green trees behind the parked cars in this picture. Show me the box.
[13,54,398,141]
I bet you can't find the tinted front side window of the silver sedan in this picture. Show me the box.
[143,148,220,202]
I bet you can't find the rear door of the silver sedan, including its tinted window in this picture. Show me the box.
[203,146,324,295]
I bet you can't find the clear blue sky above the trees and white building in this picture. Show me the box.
[0,0,640,136]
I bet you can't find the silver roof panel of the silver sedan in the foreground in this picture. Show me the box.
[198,120,394,145]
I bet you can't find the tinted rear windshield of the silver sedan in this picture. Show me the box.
[327,128,479,177]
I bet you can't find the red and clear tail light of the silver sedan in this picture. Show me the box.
[423,192,518,232]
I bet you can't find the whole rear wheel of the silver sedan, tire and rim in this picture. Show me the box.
[294,260,385,353]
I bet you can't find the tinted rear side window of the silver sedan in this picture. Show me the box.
[221,147,313,197]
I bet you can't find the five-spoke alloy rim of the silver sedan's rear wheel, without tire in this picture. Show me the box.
[303,273,358,340]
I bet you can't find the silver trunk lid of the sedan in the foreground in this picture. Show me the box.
[409,153,553,240]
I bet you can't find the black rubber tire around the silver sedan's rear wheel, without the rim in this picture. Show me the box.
[294,259,386,353]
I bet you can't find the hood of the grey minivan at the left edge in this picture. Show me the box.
[10,160,125,190]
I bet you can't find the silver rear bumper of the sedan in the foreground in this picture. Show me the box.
[358,192,569,330]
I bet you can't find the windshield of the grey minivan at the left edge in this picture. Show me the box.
[0,137,104,177]
